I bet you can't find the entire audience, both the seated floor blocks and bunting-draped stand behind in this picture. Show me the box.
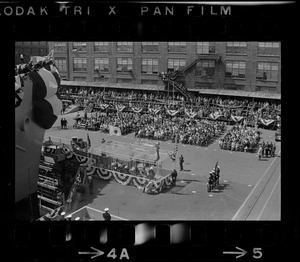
[63,88,281,152]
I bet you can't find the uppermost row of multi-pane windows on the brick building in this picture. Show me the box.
[54,42,280,56]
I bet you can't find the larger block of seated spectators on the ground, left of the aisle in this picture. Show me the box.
[76,109,226,146]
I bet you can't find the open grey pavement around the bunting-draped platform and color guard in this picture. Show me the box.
[45,113,280,220]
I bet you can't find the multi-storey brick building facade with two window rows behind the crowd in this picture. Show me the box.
[48,42,281,94]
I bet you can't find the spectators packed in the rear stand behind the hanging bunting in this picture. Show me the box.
[59,88,281,125]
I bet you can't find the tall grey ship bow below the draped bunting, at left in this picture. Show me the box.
[15,73,45,217]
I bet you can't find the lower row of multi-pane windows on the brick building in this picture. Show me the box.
[55,57,279,82]
